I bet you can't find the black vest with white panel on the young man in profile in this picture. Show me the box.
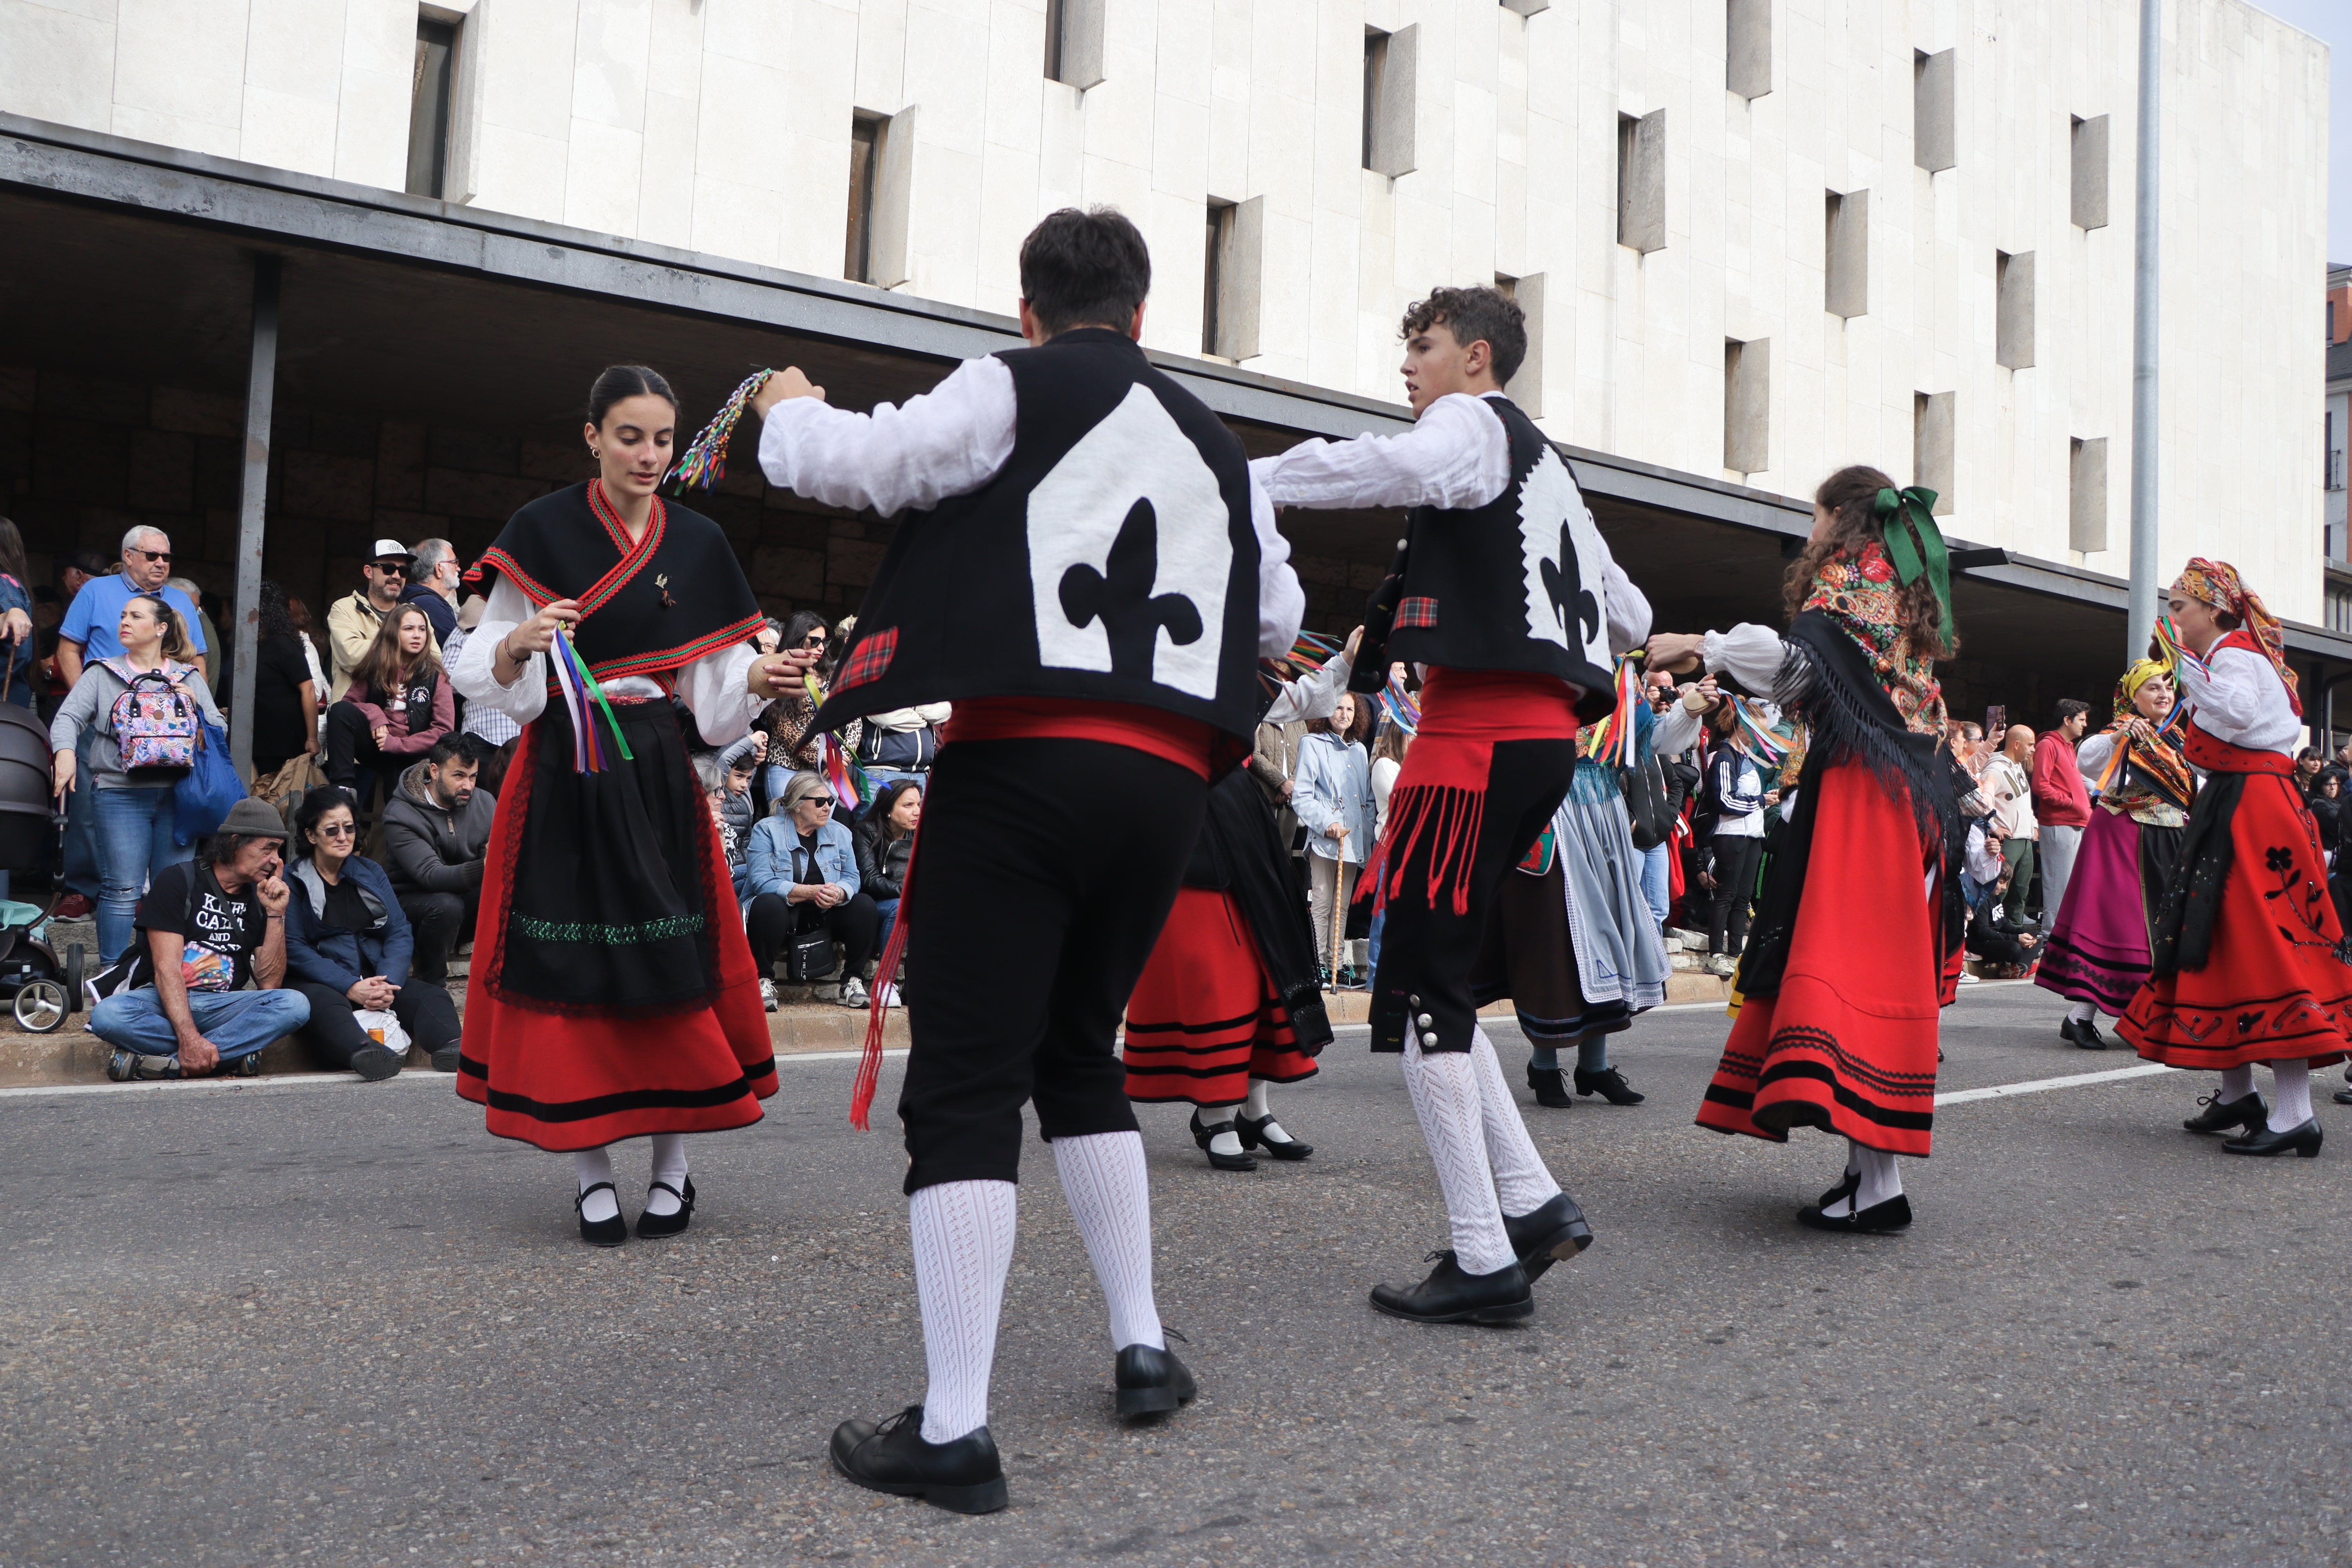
[1388,397,1613,722]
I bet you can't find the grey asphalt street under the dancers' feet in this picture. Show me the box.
[0,985,2352,1568]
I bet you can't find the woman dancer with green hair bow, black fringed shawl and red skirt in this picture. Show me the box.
[1649,468,1966,1232]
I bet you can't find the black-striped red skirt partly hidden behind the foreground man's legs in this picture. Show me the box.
[1122,889,1315,1105]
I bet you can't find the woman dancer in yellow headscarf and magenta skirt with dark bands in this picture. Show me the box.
[2034,658,2197,1051]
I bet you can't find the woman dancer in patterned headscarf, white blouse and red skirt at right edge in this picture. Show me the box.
[2114,559,2352,1159]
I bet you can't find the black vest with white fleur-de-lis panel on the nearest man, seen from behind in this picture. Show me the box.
[816,327,1258,750]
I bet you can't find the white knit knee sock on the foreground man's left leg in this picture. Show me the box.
[906,1182,1018,1443]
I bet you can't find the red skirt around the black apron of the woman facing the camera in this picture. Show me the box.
[456,708,776,1152]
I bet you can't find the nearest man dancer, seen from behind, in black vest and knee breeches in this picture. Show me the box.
[755,207,1305,1512]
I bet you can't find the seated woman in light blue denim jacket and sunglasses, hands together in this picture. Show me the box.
[743,773,882,1011]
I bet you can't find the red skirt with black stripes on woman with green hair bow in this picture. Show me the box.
[1698,764,1945,1154]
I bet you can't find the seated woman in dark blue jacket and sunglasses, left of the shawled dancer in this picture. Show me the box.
[287,785,456,1082]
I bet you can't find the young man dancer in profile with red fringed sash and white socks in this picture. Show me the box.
[1254,289,1649,1323]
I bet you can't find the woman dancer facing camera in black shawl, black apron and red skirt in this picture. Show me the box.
[452,365,807,1246]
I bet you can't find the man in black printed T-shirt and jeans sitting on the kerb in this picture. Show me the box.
[89,799,310,1082]
